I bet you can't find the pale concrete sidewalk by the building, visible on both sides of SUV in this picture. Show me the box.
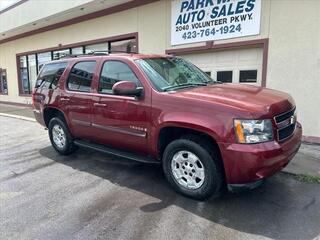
[0,104,320,177]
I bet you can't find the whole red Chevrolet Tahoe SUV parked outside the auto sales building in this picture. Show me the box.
[33,53,302,199]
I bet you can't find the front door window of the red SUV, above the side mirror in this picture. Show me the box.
[99,61,141,94]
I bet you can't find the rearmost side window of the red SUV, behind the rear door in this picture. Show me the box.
[35,62,68,89]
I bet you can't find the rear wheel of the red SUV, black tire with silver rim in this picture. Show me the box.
[48,117,76,155]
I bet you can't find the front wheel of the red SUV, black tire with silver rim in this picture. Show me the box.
[162,138,224,200]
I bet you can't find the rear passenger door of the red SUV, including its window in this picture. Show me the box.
[60,60,97,139]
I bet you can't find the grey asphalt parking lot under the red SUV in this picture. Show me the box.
[0,117,320,240]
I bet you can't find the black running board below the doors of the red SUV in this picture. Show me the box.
[74,140,160,164]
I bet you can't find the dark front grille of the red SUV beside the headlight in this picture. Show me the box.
[274,108,296,142]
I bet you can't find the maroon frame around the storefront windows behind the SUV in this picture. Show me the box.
[16,32,139,97]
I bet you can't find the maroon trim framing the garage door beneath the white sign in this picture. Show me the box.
[166,38,269,87]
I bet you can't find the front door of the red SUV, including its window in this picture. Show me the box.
[92,60,150,154]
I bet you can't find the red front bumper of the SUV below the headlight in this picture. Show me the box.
[218,123,302,186]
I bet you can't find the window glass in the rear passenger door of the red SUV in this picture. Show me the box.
[67,61,96,92]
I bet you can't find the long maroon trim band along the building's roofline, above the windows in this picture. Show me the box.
[0,0,159,44]
